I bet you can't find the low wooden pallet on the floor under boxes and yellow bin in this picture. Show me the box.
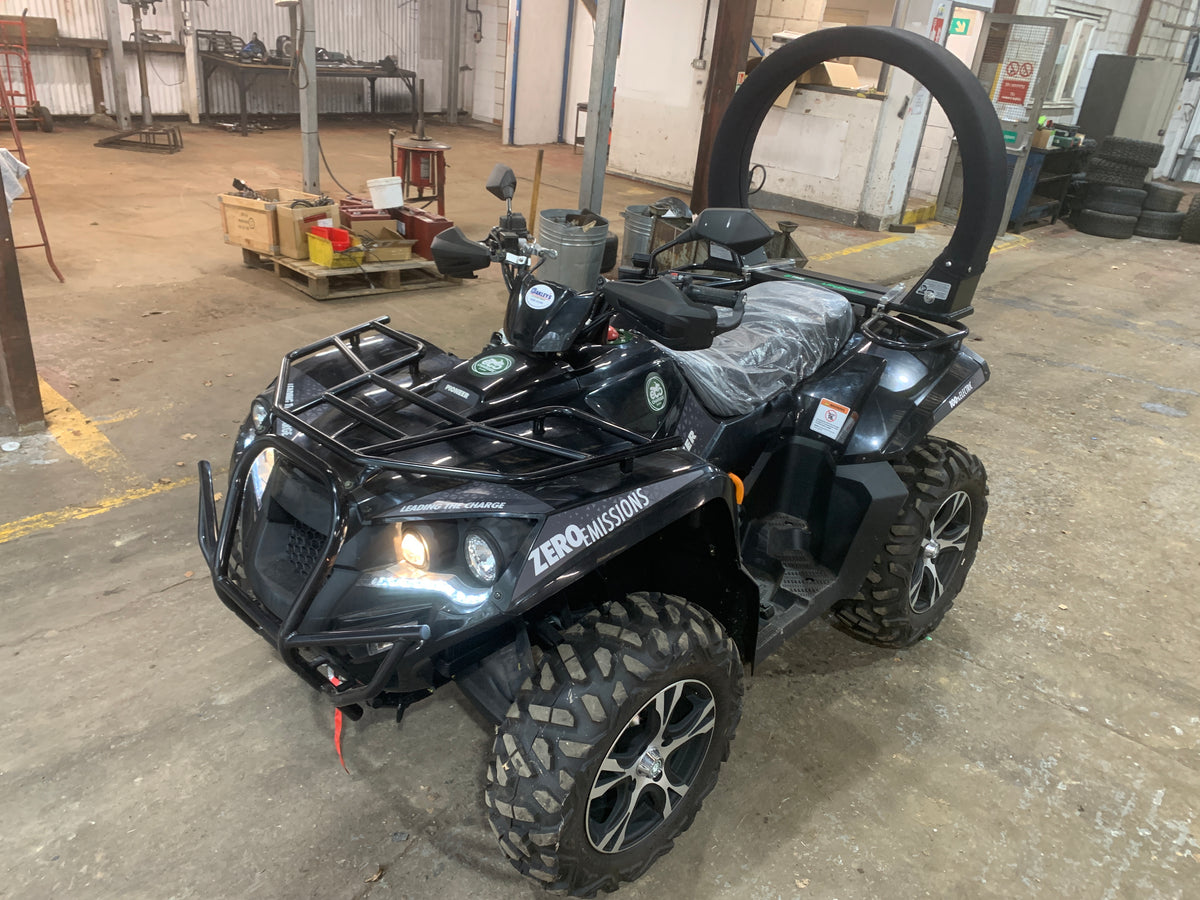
[241,247,460,300]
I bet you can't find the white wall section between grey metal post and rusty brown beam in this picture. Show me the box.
[608,0,716,190]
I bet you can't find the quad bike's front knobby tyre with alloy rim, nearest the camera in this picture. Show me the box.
[485,594,743,896]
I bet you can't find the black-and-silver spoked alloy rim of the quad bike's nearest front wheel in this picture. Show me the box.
[587,678,716,853]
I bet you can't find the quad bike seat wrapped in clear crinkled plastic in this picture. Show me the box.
[664,282,854,418]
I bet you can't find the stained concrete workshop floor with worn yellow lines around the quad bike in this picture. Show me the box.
[0,122,1200,900]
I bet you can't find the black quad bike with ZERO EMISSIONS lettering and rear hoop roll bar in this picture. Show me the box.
[199,28,1004,896]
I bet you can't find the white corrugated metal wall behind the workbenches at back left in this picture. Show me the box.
[15,0,422,115]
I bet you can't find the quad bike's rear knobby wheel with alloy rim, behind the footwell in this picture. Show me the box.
[832,437,988,647]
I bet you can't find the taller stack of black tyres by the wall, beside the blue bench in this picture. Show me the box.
[1075,138,1161,240]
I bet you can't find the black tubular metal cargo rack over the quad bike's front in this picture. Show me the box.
[270,316,682,484]
